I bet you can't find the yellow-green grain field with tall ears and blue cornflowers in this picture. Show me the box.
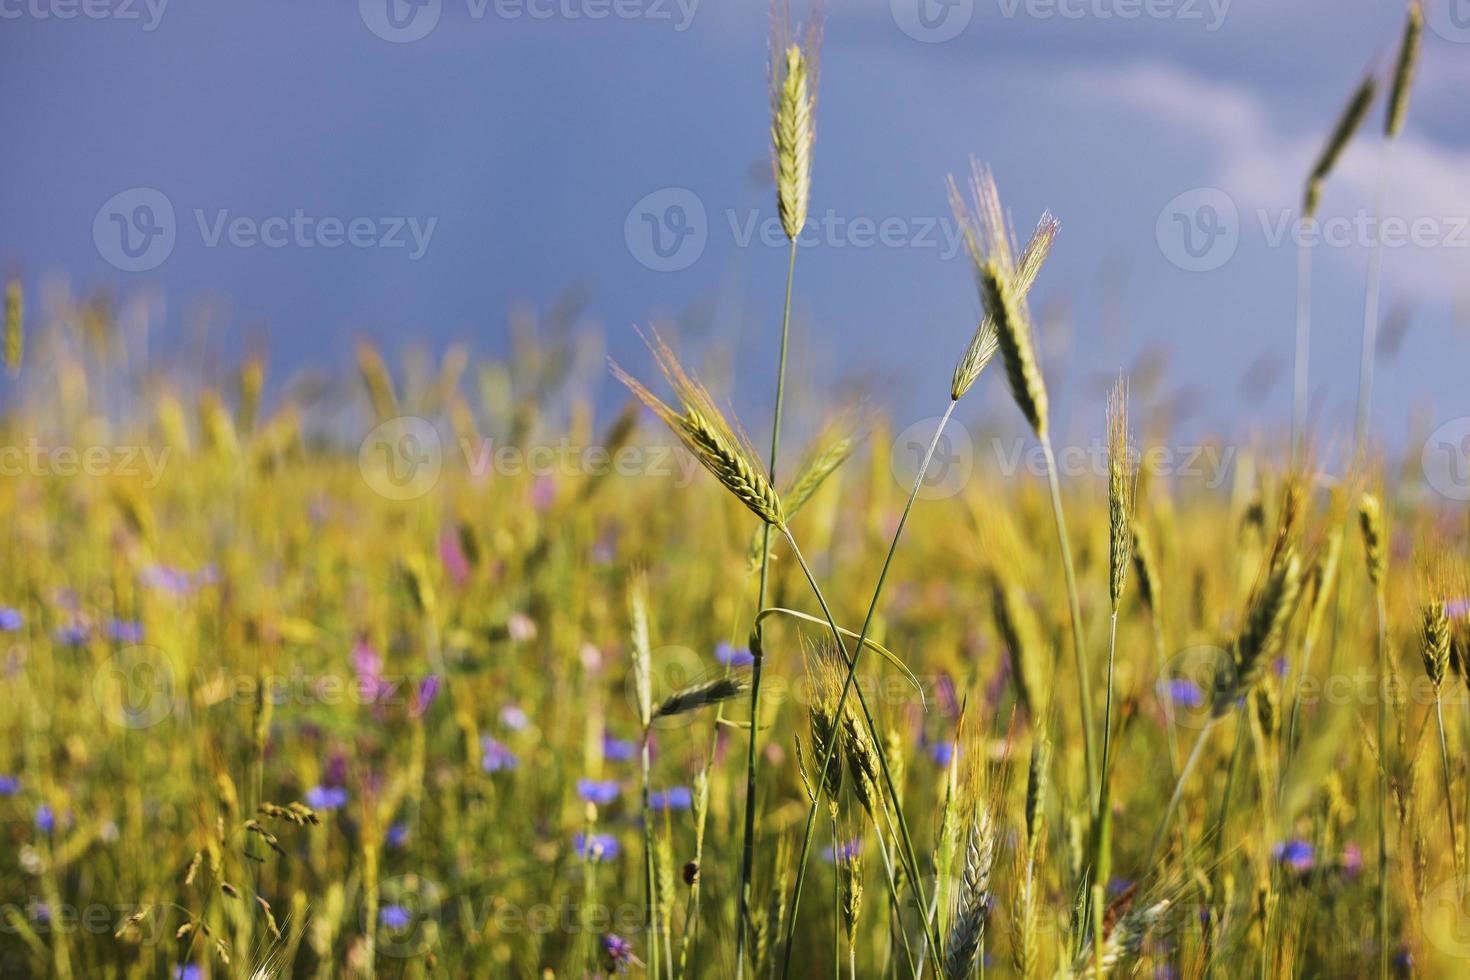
[0,3,1470,980]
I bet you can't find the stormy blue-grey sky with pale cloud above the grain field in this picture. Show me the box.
[0,0,1470,461]
